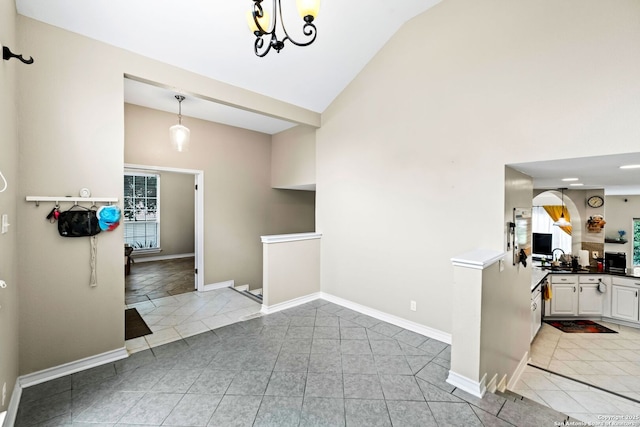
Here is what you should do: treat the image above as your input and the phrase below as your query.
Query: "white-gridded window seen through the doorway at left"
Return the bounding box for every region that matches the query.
[124,172,160,252]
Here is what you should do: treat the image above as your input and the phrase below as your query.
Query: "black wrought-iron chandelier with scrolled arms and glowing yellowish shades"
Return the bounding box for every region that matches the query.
[248,0,320,57]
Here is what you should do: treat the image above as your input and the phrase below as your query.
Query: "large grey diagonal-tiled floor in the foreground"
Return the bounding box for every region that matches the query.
[17,298,567,427]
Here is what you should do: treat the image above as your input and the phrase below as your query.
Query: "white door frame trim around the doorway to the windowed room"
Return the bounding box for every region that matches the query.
[124,163,204,291]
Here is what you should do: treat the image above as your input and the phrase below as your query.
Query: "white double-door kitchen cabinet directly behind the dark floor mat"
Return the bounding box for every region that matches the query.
[550,275,604,316]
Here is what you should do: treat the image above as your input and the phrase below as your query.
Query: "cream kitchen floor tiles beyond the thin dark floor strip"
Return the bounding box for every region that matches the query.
[531,321,640,404]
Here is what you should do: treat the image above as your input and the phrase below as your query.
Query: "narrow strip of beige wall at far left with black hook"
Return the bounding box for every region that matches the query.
[0,0,19,412]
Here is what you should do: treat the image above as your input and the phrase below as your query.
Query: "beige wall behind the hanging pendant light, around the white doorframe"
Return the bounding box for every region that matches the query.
[125,104,314,289]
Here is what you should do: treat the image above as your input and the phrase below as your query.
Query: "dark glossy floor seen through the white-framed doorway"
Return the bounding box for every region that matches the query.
[124,257,195,304]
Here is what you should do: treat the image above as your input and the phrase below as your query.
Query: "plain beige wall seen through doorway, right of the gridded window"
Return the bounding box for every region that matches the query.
[131,170,195,259]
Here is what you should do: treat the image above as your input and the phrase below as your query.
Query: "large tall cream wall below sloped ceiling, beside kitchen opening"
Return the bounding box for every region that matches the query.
[316,0,640,338]
